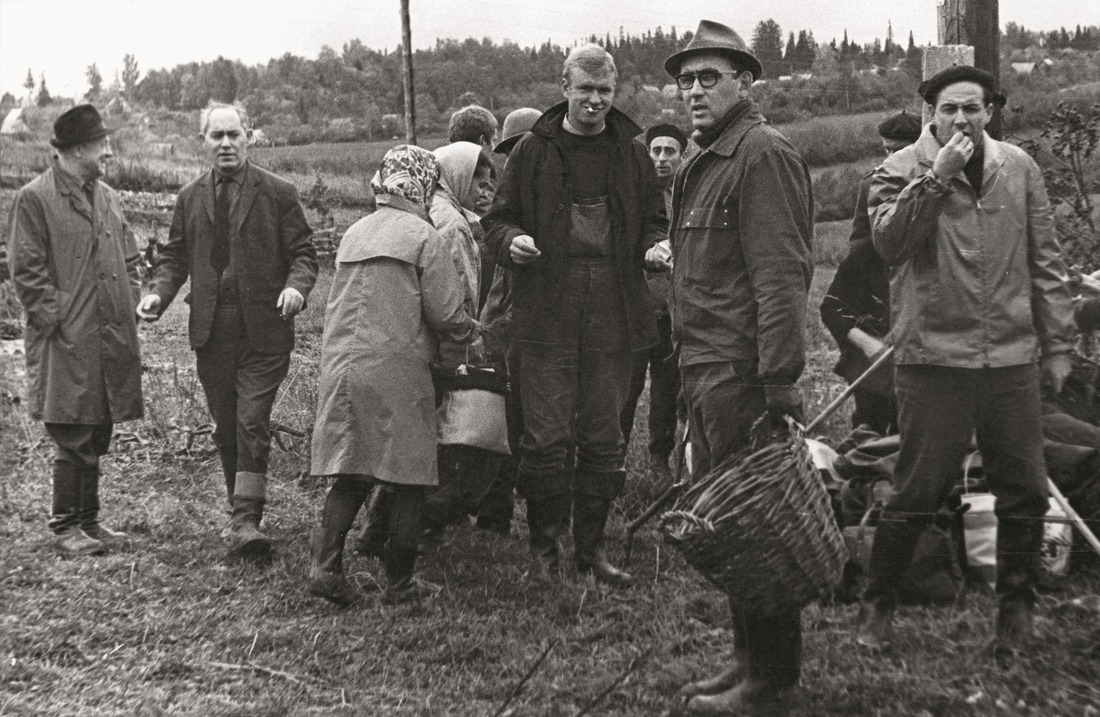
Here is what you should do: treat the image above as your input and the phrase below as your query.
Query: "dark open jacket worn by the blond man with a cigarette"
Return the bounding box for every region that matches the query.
[482,102,668,351]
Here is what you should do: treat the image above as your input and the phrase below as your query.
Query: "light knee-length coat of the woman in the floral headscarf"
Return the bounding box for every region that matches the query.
[311,195,475,485]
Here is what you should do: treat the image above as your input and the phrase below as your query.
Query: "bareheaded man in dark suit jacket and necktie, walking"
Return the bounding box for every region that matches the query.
[138,102,317,559]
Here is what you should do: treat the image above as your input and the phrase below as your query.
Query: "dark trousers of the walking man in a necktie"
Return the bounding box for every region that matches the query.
[195,305,290,497]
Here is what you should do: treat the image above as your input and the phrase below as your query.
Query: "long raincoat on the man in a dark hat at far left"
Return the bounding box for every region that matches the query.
[8,161,142,424]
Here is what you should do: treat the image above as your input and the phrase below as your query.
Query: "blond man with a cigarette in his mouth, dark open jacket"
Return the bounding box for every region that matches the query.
[482,44,667,586]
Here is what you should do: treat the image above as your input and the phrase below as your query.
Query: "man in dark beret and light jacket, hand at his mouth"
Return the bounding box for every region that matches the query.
[857,66,1074,652]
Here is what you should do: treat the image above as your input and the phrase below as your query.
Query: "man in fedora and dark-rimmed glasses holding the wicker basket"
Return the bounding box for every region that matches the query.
[649,20,814,714]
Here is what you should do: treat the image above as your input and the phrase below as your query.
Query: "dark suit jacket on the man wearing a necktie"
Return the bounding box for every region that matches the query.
[152,164,317,353]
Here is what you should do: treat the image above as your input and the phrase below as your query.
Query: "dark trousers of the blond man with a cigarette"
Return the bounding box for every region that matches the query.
[516,260,630,499]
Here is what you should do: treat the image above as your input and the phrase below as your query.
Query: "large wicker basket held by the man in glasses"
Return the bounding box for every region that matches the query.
[661,419,848,613]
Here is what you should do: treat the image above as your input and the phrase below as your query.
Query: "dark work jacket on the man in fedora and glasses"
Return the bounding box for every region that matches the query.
[670,104,814,385]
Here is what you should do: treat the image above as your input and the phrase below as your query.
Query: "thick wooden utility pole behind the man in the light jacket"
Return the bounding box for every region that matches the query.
[924,0,1001,140]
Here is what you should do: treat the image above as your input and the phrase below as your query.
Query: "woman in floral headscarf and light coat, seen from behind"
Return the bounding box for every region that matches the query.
[309,145,480,604]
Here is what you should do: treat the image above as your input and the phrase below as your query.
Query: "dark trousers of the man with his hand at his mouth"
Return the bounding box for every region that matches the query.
[883,364,1049,523]
